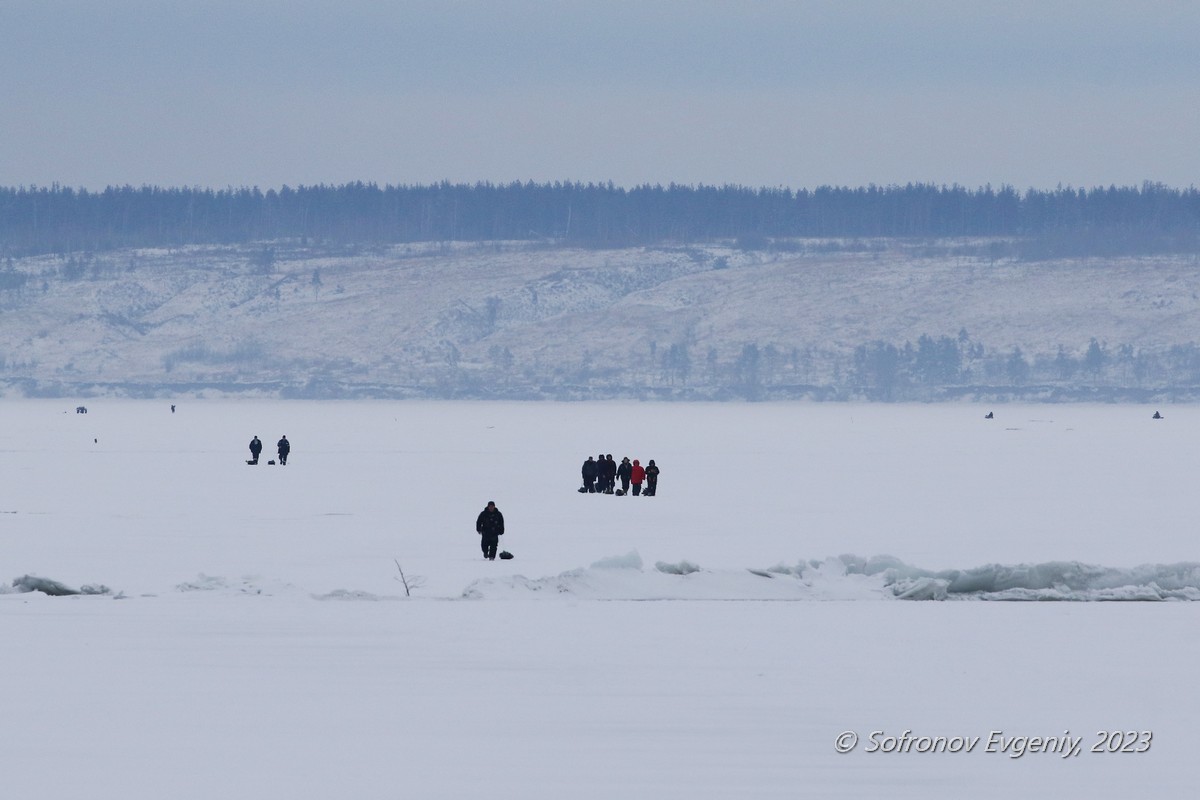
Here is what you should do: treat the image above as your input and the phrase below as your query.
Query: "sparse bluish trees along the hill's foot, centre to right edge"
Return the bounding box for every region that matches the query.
[456,329,1200,402]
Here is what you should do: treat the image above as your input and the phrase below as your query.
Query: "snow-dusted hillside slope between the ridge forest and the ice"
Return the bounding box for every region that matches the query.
[0,241,1200,399]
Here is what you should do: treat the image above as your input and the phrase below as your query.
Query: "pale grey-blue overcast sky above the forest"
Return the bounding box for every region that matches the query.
[0,0,1200,190]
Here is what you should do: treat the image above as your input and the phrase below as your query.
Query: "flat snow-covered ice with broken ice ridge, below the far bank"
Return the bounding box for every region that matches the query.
[0,399,1200,800]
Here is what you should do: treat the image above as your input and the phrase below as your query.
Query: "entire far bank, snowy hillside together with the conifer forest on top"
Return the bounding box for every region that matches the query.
[7,182,1200,401]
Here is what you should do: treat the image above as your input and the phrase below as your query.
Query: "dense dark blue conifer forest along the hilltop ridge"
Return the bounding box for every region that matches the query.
[0,182,1200,258]
